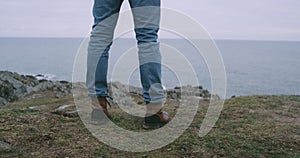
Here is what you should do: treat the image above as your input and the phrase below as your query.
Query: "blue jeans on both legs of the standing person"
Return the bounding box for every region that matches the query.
[86,0,164,103]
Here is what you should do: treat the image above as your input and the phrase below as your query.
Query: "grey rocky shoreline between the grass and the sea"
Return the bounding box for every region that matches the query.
[0,71,213,105]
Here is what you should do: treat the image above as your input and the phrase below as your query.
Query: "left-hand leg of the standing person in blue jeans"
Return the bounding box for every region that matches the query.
[86,0,123,97]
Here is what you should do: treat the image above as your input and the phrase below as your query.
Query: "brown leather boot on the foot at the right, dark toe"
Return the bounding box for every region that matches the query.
[143,109,170,129]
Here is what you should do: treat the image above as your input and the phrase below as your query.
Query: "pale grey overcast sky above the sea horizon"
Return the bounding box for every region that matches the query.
[0,0,300,41]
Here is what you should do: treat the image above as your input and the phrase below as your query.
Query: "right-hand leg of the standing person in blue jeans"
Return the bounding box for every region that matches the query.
[129,0,164,103]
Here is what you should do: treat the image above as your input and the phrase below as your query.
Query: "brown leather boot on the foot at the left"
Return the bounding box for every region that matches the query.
[91,97,112,125]
